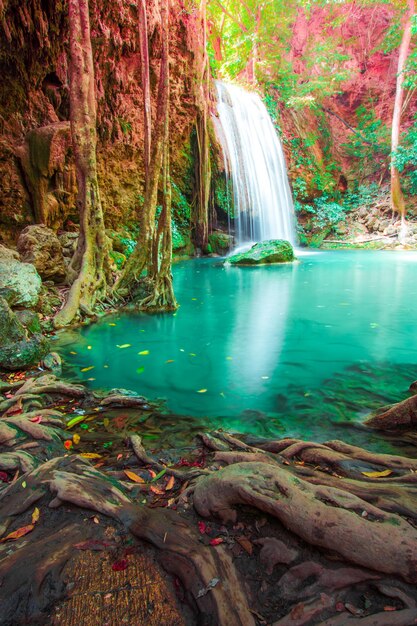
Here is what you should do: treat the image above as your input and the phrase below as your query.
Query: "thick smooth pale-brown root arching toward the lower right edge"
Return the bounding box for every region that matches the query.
[193,463,417,582]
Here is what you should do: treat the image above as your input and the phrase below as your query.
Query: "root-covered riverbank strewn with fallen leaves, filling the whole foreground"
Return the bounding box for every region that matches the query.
[0,364,417,626]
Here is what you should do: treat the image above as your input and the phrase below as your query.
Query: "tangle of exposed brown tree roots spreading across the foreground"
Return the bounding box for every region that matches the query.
[0,377,417,626]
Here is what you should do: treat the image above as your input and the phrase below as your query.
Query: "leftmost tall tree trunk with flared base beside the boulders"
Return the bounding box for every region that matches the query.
[54,0,108,327]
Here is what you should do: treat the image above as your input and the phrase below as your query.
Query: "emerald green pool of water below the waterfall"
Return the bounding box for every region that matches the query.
[57,251,417,447]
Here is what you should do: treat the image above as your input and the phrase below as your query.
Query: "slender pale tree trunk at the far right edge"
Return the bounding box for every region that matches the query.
[391,0,414,225]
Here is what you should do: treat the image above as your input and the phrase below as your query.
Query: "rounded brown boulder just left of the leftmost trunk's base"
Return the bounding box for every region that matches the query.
[17,224,66,282]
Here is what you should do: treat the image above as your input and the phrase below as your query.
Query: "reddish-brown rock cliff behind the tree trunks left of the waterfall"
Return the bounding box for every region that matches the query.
[0,0,200,242]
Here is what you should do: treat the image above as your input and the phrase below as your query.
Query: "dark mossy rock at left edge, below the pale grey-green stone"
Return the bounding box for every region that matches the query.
[0,297,49,370]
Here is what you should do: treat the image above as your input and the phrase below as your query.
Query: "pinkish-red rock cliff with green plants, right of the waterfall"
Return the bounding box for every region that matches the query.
[283,2,417,197]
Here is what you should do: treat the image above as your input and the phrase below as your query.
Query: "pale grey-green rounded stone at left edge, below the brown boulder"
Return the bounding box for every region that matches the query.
[0,259,42,308]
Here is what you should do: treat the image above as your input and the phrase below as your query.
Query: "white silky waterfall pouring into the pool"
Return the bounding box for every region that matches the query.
[216,82,295,245]
